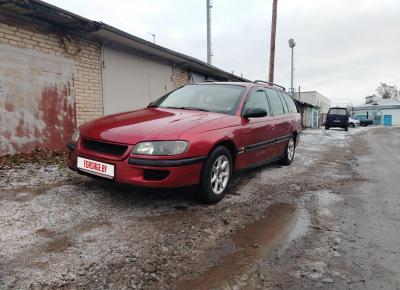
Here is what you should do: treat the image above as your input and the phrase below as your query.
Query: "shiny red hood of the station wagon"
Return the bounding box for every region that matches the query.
[80,108,227,144]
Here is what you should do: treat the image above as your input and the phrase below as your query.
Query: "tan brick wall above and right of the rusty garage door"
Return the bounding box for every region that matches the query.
[0,23,103,126]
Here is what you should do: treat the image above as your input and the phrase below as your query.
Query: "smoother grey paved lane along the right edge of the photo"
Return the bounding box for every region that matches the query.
[335,128,400,289]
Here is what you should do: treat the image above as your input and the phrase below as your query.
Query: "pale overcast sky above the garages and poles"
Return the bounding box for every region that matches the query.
[47,0,400,105]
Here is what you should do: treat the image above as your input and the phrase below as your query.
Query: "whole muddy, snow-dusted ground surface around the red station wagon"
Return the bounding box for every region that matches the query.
[0,128,400,289]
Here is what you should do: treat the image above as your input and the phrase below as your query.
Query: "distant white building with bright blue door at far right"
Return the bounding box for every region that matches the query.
[351,96,400,126]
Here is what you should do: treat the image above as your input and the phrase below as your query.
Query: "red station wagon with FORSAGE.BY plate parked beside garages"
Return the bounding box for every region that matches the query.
[68,81,301,203]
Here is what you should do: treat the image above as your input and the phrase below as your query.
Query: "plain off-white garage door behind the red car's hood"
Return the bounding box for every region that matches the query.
[103,47,173,115]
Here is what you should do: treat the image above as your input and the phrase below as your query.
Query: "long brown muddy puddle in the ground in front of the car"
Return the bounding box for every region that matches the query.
[176,203,309,289]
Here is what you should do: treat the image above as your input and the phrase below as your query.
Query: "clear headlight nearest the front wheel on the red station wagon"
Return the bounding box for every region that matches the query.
[132,141,188,155]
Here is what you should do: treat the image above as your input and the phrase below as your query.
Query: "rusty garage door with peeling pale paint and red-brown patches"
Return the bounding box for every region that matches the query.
[0,45,75,155]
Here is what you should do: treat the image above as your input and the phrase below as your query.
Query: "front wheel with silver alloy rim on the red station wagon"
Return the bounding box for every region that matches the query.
[198,146,233,204]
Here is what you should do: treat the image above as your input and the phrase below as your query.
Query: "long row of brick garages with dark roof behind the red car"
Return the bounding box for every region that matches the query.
[0,0,245,155]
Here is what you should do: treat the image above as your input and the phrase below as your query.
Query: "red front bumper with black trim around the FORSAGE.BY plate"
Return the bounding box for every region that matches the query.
[67,144,205,188]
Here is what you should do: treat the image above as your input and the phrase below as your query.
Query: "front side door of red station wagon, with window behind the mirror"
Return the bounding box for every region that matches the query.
[241,87,275,167]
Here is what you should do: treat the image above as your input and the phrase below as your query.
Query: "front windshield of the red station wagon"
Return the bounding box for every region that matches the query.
[154,85,245,115]
